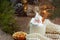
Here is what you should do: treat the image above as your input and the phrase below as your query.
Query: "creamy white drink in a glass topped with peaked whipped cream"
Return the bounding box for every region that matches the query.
[30,12,46,35]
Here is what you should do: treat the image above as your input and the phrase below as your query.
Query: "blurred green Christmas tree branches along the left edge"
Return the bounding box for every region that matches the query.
[0,0,16,34]
